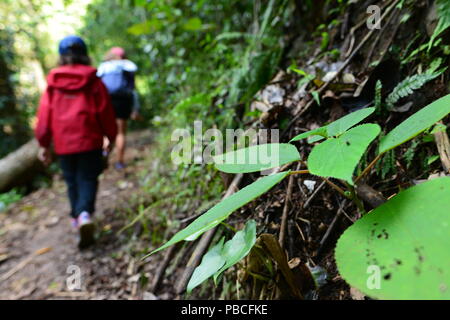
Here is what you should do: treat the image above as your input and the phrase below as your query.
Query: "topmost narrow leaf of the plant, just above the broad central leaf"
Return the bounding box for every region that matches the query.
[290,108,375,142]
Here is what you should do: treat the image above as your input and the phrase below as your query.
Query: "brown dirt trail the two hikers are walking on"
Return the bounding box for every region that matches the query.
[0,131,168,299]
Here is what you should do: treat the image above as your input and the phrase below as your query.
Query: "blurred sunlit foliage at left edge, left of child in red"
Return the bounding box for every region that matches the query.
[0,0,85,157]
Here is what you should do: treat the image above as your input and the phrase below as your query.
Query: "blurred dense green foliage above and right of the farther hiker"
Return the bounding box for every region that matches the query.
[82,0,290,127]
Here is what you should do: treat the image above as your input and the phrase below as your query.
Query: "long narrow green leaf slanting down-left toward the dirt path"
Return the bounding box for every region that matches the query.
[150,171,290,254]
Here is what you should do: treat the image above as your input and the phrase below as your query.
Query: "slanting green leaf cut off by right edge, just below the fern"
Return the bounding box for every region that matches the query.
[379,94,450,154]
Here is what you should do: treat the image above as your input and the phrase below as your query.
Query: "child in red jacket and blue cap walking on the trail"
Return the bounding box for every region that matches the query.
[35,36,117,248]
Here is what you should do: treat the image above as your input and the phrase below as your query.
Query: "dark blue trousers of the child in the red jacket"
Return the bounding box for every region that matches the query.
[59,150,103,218]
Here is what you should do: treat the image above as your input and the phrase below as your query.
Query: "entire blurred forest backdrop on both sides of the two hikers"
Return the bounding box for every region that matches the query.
[0,0,295,195]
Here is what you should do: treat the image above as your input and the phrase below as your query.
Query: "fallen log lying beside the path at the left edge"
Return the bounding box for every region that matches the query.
[0,139,41,192]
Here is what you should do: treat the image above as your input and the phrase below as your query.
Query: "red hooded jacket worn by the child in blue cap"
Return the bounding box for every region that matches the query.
[35,64,117,155]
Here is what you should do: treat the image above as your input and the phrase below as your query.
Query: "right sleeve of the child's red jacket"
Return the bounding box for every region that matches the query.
[95,79,117,145]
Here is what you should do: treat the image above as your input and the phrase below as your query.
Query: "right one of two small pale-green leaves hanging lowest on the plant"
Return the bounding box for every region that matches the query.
[214,220,256,281]
